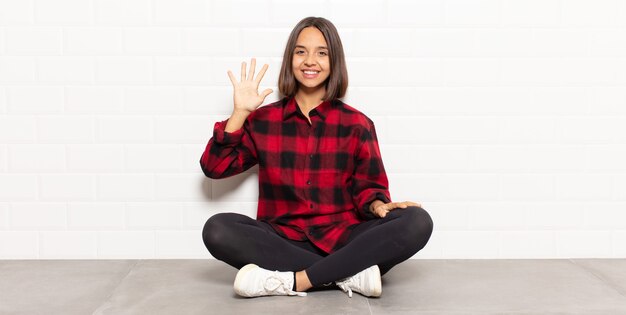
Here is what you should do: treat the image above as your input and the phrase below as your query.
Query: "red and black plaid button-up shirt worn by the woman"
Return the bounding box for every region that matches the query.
[200,97,391,253]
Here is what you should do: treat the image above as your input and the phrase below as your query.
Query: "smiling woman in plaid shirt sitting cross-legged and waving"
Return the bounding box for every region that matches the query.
[200,17,433,297]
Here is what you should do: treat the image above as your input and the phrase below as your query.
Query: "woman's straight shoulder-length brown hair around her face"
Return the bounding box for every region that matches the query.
[278,16,348,101]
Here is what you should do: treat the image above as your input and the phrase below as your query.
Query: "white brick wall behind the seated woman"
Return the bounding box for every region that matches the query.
[0,0,626,259]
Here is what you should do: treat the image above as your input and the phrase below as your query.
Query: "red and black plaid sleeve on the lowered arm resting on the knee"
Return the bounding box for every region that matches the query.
[352,123,391,220]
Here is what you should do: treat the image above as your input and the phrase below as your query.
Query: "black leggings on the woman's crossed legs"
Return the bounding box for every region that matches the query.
[202,206,433,287]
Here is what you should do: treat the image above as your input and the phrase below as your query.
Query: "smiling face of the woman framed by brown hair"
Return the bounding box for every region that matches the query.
[292,26,330,89]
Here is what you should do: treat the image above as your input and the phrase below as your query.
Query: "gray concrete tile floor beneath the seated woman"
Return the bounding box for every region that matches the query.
[0,259,626,314]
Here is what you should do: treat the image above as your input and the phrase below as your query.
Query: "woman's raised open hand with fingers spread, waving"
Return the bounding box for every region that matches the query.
[228,58,273,114]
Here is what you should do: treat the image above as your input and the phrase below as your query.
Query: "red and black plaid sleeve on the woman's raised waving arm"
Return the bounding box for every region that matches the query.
[200,115,258,179]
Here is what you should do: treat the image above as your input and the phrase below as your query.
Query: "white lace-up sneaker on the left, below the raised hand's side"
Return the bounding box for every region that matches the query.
[234,264,306,297]
